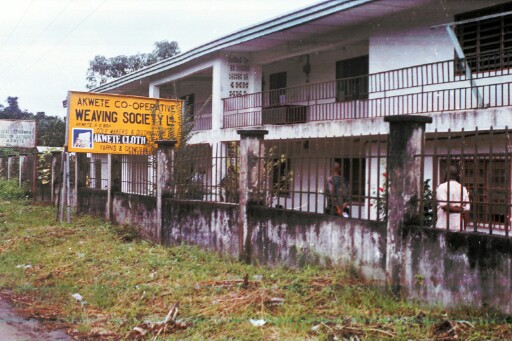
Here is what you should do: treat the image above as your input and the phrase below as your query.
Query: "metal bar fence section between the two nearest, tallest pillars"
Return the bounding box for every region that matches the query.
[251,135,387,221]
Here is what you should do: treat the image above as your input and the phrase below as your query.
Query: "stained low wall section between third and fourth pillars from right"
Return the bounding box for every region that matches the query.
[111,193,160,243]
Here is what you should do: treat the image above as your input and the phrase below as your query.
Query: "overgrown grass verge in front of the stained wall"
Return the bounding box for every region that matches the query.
[0,195,512,340]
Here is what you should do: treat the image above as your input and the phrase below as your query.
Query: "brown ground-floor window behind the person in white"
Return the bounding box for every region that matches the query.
[440,157,510,224]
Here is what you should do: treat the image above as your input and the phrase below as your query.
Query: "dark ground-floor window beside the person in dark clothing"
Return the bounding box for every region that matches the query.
[334,158,366,203]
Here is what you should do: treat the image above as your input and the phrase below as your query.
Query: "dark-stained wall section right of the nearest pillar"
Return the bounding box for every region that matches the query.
[403,227,512,314]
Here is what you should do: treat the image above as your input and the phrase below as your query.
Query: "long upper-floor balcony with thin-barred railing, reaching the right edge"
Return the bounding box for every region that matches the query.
[223,53,512,128]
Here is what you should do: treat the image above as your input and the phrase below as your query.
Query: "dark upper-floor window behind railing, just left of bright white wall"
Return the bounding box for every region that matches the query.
[336,55,368,102]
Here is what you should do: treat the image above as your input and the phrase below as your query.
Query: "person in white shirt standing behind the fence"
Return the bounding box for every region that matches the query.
[436,165,470,231]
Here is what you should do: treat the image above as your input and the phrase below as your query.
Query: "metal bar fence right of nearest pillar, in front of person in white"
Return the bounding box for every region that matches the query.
[418,127,512,236]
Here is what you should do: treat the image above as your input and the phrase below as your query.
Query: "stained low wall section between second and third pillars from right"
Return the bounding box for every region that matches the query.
[162,199,239,257]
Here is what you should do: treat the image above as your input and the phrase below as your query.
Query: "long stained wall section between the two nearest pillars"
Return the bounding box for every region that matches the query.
[249,207,386,281]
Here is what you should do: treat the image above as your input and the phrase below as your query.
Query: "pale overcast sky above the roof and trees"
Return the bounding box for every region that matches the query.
[0,0,319,117]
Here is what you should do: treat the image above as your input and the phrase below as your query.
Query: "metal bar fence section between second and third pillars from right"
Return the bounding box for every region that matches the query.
[173,142,240,203]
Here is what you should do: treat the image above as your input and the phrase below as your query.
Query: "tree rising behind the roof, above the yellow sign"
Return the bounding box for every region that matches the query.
[86,40,180,89]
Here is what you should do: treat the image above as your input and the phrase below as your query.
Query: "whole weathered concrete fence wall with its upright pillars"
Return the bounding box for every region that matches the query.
[70,116,512,313]
